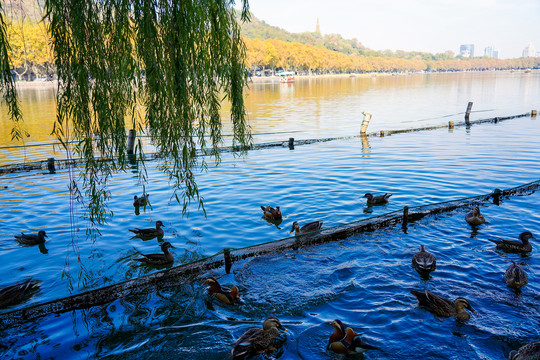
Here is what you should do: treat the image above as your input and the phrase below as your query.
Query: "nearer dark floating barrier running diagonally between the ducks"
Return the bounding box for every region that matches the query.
[0,180,540,330]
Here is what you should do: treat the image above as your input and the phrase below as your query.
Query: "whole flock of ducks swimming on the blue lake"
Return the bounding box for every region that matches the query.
[0,193,540,360]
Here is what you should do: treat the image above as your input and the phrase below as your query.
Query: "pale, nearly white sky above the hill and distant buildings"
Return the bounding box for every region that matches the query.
[242,0,540,59]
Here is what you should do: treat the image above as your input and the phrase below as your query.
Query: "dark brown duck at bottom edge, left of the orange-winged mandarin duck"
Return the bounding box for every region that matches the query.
[231,316,287,359]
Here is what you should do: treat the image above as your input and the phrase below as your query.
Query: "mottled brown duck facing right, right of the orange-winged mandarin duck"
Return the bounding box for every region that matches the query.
[411,290,476,322]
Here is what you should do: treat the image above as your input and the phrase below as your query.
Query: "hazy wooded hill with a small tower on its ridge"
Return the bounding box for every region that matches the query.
[238,13,370,55]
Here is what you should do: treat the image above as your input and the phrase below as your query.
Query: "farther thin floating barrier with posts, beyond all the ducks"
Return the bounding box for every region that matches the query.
[0,113,531,175]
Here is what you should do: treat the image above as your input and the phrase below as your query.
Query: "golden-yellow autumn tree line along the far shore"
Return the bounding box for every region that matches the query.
[7,21,540,80]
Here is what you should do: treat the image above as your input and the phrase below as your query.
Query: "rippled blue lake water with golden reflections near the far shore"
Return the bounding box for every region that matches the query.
[0,72,540,359]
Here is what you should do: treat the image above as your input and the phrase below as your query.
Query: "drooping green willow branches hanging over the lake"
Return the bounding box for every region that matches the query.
[0,0,251,223]
